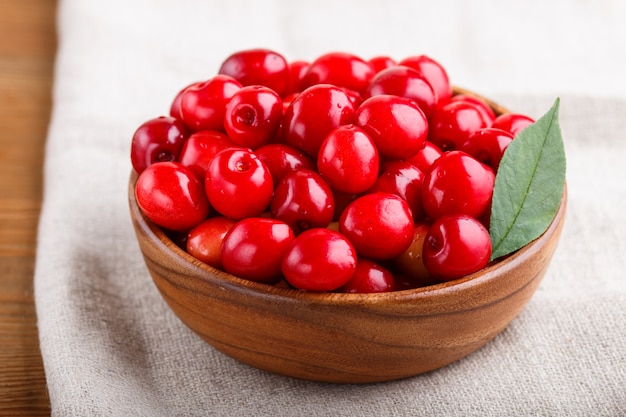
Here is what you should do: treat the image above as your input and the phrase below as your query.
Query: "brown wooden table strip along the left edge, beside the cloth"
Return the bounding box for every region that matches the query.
[0,0,57,416]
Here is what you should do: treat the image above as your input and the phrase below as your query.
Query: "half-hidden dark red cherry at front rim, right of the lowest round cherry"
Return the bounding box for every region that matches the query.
[339,258,395,294]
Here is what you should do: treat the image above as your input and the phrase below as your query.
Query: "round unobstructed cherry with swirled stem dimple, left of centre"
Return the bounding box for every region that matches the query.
[205,148,274,220]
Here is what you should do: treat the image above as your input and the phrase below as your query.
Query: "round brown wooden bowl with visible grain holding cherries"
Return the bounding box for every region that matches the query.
[128,92,567,383]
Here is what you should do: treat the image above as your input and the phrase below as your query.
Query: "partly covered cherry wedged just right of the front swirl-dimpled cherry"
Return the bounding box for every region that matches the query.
[254,143,315,186]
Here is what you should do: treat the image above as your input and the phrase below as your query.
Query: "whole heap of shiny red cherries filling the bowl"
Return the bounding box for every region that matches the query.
[131,49,533,293]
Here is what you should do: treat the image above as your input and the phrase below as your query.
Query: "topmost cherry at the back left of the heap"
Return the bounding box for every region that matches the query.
[219,49,289,96]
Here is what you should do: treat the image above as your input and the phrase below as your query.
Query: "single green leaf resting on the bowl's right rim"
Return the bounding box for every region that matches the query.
[489,98,565,260]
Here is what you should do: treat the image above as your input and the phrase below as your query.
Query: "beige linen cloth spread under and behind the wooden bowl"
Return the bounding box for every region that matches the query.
[35,0,626,417]
